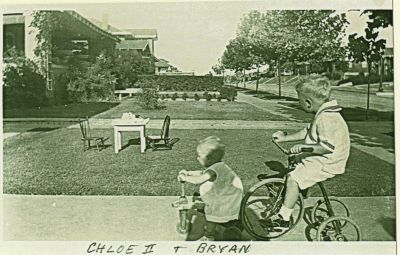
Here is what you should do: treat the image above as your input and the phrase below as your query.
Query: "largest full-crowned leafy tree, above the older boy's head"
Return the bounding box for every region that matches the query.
[245,10,347,96]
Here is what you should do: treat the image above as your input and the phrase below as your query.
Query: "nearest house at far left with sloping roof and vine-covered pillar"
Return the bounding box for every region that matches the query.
[3,11,120,103]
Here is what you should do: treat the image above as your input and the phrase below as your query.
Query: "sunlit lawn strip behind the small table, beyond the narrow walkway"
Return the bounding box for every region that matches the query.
[92,99,282,121]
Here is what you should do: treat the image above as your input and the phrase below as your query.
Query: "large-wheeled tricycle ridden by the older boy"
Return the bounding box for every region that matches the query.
[240,140,361,241]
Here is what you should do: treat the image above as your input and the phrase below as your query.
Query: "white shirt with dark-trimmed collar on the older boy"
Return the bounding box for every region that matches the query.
[305,100,350,174]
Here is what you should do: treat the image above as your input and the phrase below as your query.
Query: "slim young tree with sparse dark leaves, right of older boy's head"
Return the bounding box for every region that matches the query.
[348,11,386,119]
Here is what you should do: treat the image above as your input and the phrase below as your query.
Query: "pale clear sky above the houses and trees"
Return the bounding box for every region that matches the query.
[3,0,393,74]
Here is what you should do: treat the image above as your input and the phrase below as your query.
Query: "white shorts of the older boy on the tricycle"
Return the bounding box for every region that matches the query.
[290,158,335,190]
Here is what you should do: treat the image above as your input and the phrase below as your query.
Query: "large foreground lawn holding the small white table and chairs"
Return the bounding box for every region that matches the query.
[3,128,395,196]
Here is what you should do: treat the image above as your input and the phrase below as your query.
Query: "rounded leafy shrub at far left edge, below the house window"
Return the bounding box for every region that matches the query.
[3,50,48,108]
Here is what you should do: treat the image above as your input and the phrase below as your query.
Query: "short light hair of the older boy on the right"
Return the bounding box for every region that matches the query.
[296,75,331,102]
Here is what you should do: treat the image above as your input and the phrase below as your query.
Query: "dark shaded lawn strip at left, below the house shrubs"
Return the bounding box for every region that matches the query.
[3,102,119,118]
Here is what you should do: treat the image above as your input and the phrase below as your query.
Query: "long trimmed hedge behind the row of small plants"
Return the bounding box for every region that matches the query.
[135,75,223,91]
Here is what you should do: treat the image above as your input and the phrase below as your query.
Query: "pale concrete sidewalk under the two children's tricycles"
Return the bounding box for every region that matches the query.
[2,195,395,241]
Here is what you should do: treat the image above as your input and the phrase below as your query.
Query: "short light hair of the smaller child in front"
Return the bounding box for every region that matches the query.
[197,136,225,165]
